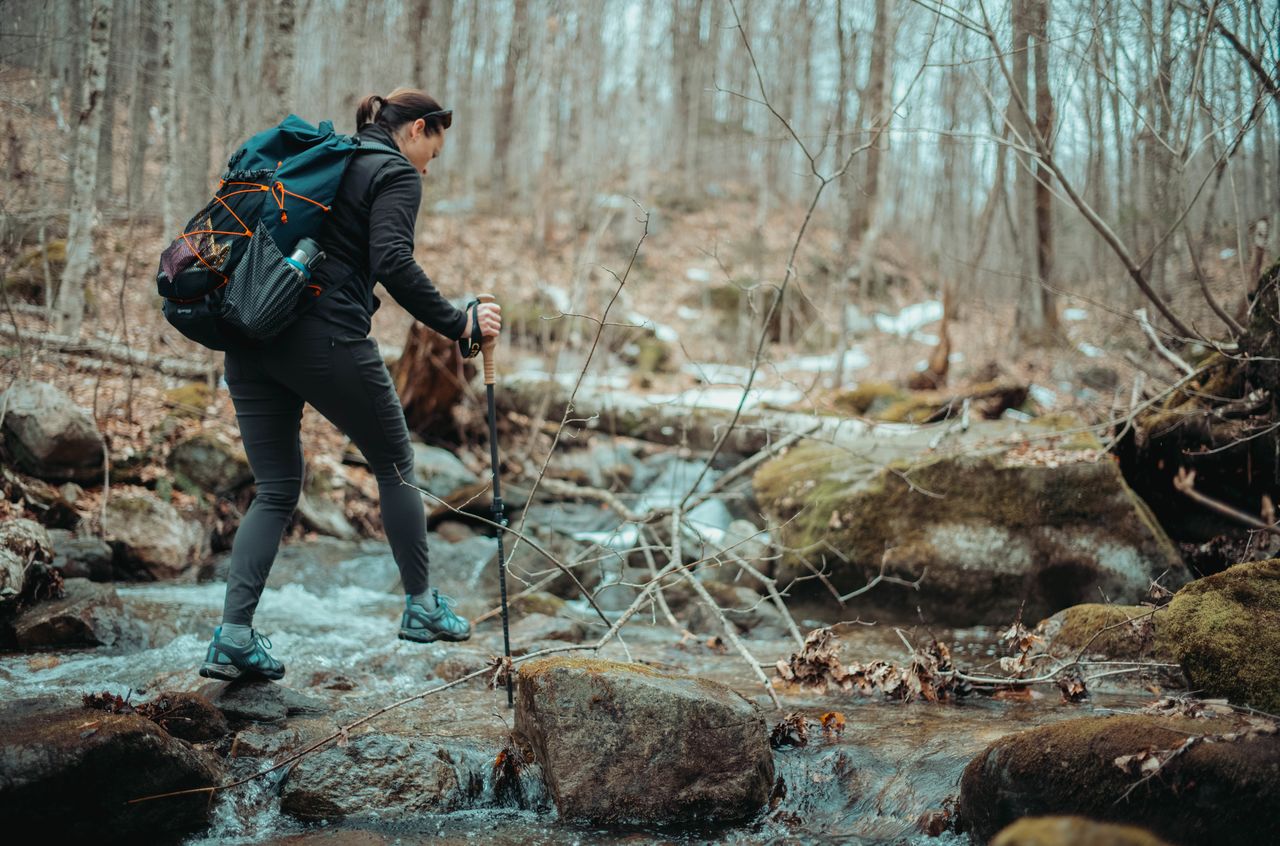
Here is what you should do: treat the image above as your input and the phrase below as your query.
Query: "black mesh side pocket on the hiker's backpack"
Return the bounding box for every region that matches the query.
[221,224,307,340]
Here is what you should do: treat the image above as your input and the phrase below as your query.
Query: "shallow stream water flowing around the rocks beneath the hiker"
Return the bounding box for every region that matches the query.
[0,538,1157,846]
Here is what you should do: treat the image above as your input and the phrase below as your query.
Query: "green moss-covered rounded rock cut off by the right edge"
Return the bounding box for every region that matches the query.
[1161,558,1280,713]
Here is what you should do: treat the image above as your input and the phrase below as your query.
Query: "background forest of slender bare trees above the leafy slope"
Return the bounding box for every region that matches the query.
[0,0,1280,335]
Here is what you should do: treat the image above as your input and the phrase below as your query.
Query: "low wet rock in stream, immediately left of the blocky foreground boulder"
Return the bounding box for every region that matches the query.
[280,732,495,822]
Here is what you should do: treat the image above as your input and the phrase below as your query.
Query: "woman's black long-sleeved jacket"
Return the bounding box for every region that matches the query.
[310,124,466,339]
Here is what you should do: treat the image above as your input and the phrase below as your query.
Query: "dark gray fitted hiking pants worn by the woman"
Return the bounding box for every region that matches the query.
[223,316,428,626]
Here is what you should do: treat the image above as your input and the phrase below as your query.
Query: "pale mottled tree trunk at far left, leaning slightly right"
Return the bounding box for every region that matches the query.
[55,0,111,338]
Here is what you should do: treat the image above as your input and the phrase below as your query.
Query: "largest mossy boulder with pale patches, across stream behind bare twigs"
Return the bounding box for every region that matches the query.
[754,422,1189,625]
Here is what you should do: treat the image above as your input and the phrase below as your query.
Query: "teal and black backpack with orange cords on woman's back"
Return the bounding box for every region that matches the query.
[156,114,399,349]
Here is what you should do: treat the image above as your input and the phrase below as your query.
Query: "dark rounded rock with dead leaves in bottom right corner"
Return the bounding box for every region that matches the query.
[960,714,1280,846]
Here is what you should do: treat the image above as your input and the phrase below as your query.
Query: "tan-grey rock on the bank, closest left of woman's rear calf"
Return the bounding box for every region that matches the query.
[102,493,207,579]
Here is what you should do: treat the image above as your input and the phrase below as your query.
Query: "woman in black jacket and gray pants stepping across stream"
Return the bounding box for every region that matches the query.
[200,88,502,680]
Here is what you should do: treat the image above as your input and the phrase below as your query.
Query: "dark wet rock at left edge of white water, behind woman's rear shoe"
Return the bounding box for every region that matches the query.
[13,579,127,649]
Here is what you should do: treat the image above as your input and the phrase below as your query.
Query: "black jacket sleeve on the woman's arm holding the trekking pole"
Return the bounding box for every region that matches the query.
[369,159,467,340]
